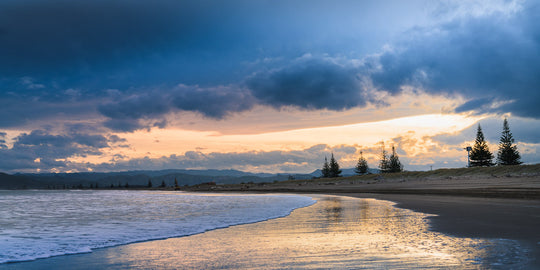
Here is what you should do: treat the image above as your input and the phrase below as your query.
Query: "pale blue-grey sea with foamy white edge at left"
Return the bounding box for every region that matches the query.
[0,190,315,263]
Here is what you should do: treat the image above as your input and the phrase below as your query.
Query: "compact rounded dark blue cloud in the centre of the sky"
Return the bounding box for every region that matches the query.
[247,57,366,110]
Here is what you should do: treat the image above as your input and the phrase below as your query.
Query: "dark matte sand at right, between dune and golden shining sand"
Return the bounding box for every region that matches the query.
[348,194,540,269]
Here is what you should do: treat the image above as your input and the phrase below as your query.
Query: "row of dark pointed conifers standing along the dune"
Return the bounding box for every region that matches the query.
[321,118,522,178]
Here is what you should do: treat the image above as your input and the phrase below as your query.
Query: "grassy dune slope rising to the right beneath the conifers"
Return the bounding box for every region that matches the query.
[187,164,540,199]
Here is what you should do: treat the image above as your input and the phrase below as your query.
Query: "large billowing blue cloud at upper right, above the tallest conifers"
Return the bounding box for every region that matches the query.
[371,4,540,118]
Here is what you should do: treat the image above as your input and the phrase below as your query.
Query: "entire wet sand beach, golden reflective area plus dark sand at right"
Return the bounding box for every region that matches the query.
[0,194,539,269]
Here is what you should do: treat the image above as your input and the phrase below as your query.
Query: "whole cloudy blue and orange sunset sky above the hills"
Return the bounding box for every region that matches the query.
[0,0,540,173]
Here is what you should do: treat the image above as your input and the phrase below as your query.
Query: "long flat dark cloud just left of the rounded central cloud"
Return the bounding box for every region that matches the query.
[99,85,255,131]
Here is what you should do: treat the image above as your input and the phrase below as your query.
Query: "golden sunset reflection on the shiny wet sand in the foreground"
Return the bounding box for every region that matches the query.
[96,195,519,269]
